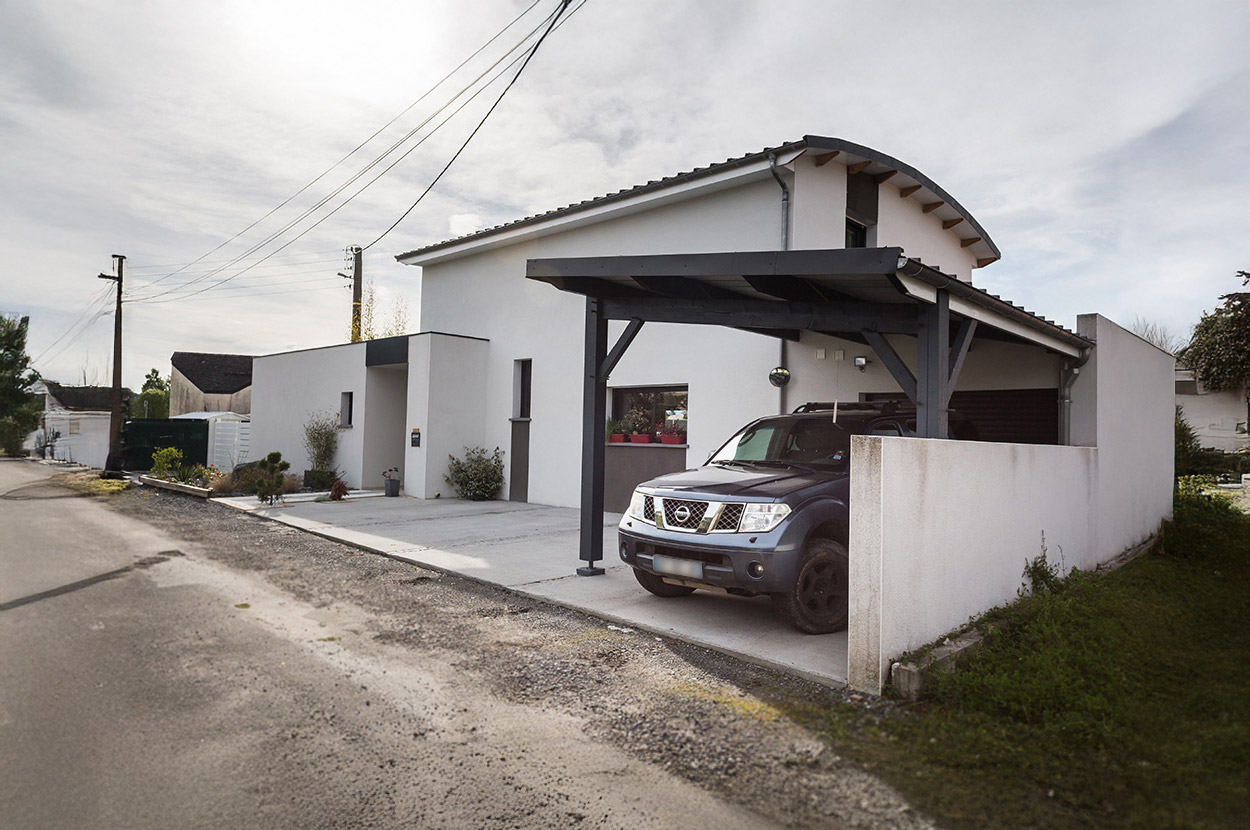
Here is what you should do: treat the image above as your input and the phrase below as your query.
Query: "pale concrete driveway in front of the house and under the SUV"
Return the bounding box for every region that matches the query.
[218,494,846,685]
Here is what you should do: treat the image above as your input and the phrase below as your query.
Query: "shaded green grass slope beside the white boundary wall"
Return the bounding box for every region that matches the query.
[795,491,1250,828]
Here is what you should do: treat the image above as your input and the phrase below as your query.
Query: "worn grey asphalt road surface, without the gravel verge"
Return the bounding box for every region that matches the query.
[0,463,768,830]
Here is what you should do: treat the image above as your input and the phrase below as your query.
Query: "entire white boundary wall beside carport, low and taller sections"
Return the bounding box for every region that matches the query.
[848,315,1174,694]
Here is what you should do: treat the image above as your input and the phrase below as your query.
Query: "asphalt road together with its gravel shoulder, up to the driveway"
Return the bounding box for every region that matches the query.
[0,461,931,830]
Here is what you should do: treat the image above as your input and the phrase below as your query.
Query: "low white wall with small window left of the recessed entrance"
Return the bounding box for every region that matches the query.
[251,343,365,488]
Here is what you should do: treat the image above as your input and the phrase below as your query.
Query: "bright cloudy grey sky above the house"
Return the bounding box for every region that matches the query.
[0,0,1250,389]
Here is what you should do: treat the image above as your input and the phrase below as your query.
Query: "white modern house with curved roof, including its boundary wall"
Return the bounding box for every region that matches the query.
[251,136,1174,690]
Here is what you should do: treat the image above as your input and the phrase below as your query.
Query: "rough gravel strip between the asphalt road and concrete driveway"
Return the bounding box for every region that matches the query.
[108,488,933,828]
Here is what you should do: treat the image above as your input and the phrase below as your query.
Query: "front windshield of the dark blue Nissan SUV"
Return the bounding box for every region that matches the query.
[709,418,851,470]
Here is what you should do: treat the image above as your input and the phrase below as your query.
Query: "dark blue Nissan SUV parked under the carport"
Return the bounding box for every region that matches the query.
[619,404,971,634]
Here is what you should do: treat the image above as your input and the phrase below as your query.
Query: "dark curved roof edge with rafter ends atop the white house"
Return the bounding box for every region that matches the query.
[395,135,1003,268]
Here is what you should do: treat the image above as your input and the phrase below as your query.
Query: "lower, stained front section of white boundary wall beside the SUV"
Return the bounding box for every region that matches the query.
[848,436,1095,694]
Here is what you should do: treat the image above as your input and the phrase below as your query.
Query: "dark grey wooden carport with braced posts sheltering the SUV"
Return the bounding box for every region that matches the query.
[526,248,1093,576]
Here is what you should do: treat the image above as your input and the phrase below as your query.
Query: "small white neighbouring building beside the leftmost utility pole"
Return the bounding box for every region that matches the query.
[35,380,131,469]
